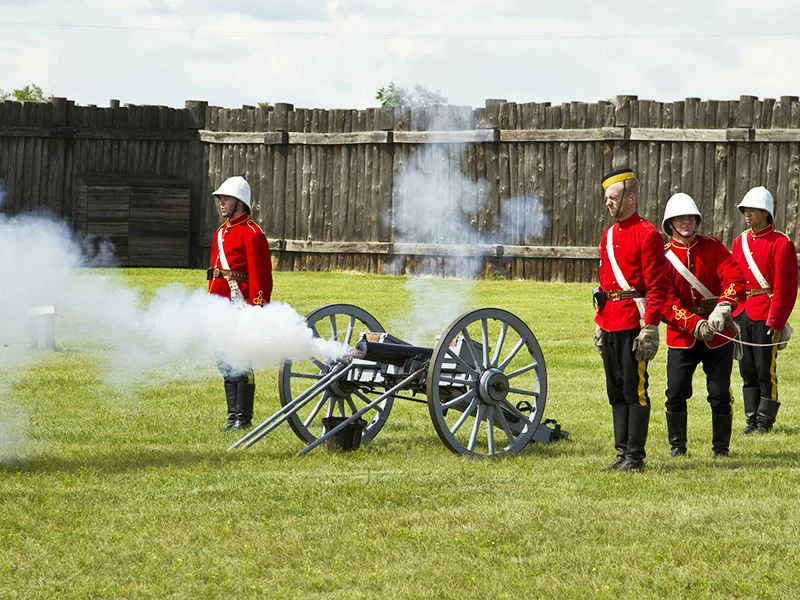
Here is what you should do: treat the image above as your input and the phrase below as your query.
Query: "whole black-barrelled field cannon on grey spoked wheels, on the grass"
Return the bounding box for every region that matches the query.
[230,304,568,456]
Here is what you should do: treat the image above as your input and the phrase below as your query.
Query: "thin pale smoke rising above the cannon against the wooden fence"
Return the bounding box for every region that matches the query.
[391,111,550,346]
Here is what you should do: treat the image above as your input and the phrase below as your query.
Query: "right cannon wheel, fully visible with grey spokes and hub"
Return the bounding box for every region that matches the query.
[427,308,547,456]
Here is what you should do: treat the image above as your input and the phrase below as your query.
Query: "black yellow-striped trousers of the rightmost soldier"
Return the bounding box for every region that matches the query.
[736,313,778,402]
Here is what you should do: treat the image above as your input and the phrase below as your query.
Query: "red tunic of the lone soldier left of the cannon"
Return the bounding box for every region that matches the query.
[208,214,272,305]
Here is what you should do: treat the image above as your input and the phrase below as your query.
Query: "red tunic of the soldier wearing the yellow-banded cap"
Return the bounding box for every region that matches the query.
[594,212,669,331]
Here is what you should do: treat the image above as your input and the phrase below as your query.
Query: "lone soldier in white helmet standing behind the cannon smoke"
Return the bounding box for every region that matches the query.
[208,176,272,431]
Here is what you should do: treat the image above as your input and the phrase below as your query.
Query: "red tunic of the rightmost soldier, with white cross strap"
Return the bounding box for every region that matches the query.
[732,225,797,329]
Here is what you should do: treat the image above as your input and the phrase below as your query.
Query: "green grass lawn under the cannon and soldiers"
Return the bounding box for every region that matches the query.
[0,269,800,599]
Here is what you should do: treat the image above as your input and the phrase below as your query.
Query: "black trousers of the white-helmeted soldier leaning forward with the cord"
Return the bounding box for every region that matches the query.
[664,341,733,415]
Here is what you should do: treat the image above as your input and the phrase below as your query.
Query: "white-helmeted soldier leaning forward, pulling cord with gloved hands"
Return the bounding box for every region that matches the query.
[661,193,744,458]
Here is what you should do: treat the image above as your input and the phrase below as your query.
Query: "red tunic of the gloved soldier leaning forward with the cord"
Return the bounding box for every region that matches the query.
[662,235,744,348]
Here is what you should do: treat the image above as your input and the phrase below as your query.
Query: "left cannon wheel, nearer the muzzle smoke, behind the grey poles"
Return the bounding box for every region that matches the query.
[278,304,393,444]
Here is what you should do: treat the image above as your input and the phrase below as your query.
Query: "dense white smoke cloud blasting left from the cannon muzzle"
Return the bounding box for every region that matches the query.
[0,214,348,458]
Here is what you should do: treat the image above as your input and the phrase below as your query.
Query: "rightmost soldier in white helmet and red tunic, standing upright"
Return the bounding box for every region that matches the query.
[732,186,797,434]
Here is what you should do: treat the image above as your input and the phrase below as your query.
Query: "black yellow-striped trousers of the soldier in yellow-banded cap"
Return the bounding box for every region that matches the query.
[601,327,650,406]
